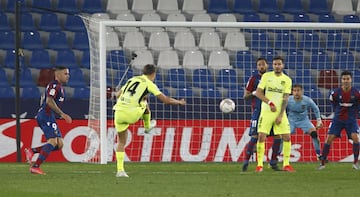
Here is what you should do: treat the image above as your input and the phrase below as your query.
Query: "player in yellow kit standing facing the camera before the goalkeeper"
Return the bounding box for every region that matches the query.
[256,57,294,172]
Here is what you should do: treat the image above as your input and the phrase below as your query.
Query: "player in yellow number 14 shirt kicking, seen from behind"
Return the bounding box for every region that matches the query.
[113,64,186,177]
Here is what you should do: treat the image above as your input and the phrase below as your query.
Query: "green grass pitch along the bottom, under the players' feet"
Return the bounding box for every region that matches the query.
[0,162,360,197]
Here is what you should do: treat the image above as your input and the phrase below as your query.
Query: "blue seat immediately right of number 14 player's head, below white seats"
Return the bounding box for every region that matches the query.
[166,68,187,88]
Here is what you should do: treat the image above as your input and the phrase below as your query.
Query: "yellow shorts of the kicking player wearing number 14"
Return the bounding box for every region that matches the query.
[114,107,146,132]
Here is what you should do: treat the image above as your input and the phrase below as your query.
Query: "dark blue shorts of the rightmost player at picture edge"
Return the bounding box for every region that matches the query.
[328,120,359,139]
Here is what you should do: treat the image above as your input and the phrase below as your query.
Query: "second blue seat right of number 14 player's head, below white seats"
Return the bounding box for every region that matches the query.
[192,68,214,89]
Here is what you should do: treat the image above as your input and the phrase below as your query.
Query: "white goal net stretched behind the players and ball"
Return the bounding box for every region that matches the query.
[83,17,360,163]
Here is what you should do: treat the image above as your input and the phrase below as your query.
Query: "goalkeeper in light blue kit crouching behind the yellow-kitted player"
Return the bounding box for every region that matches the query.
[287,84,323,159]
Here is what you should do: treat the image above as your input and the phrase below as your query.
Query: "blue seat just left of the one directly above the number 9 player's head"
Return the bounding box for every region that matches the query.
[29,49,53,69]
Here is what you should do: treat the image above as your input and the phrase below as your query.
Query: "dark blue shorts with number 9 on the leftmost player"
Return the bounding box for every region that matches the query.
[36,113,62,140]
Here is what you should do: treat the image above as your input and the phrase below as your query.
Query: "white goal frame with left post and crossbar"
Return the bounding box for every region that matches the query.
[81,16,359,164]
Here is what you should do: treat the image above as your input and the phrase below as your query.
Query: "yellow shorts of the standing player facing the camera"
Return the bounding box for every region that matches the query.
[258,113,290,135]
